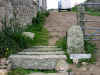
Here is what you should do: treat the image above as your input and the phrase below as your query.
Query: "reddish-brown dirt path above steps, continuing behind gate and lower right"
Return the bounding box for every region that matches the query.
[45,12,100,75]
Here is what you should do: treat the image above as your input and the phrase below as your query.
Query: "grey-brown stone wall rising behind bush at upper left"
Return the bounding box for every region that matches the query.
[0,0,38,25]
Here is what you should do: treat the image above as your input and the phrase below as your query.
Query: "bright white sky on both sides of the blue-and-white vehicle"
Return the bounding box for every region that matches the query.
[47,0,86,9]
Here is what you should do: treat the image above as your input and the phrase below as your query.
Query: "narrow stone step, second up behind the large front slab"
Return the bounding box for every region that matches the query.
[23,47,62,52]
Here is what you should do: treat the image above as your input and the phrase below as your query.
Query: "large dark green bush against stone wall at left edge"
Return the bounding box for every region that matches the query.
[0,18,32,57]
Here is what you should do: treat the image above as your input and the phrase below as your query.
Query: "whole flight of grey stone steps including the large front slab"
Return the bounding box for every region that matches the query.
[9,46,67,70]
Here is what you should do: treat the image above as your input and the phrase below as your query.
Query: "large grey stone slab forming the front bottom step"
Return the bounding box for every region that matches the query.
[9,55,66,70]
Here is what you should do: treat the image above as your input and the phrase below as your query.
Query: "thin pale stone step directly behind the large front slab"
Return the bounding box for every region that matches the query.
[18,51,64,55]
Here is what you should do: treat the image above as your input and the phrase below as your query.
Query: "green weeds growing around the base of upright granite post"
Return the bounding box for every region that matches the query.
[56,37,97,64]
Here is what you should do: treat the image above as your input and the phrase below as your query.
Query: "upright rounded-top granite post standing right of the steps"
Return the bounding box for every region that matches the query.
[67,25,85,54]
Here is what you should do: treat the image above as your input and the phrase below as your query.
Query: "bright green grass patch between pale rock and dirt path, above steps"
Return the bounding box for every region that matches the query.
[26,27,49,46]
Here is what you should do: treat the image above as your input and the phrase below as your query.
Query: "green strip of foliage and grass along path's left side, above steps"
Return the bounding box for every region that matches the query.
[26,12,49,45]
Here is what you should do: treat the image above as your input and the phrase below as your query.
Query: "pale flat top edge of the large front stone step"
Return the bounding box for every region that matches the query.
[9,55,67,59]
